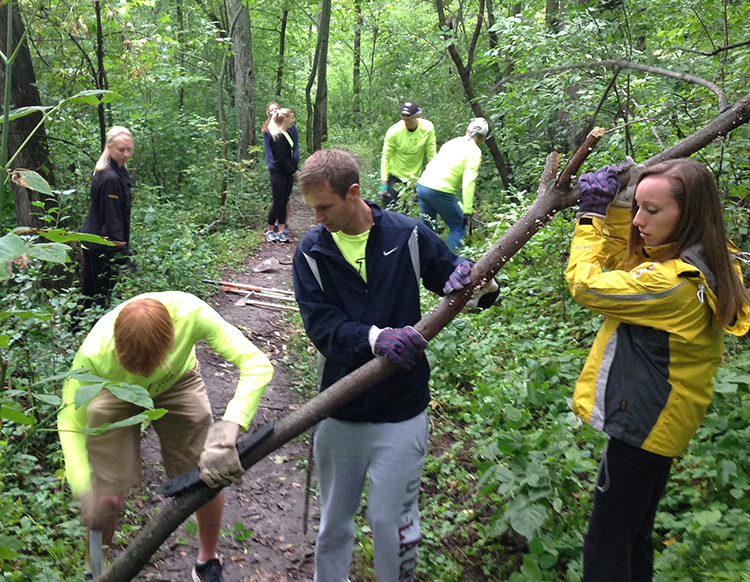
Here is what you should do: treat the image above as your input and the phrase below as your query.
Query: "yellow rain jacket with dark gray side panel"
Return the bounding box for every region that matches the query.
[566,208,750,457]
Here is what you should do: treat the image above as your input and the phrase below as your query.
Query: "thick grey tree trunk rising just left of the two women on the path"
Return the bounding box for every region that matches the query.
[232,0,255,161]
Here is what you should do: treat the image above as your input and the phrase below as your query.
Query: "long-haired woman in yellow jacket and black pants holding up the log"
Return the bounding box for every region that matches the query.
[566,159,750,582]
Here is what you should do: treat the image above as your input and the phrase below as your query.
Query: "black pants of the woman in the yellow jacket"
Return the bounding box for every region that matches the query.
[583,438,672,582]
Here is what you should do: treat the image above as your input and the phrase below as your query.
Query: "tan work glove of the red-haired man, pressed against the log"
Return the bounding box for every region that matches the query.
[198,420,245,489]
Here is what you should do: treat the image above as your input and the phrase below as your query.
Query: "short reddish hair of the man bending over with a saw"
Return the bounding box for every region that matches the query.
[115,298,174,378]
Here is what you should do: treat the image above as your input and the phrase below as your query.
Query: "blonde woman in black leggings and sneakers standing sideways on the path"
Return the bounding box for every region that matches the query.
[264,109,298,242]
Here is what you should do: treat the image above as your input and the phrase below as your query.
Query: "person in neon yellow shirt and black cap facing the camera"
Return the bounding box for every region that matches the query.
[380,101,437,207]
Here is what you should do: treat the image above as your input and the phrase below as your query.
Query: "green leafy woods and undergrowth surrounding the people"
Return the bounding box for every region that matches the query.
[0,0,750,581]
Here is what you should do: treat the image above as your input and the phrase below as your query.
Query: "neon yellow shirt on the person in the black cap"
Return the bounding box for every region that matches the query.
[380,119,437,182]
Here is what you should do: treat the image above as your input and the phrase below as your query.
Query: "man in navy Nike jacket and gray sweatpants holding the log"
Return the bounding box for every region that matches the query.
[293,150,496,582]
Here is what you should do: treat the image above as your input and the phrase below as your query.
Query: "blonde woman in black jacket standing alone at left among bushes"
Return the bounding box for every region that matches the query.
[79,126,133,320]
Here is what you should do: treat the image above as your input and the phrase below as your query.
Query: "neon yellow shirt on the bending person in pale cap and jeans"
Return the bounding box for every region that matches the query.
[419,135,482,214]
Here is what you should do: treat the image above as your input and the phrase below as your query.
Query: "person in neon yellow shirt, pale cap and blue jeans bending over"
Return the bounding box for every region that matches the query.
[417,117,490,252]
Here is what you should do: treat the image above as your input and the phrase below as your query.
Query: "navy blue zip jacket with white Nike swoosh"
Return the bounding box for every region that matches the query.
[293,202,464,422]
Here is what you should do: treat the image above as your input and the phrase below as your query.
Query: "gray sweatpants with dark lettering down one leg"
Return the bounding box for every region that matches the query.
[314,412,428,582]
